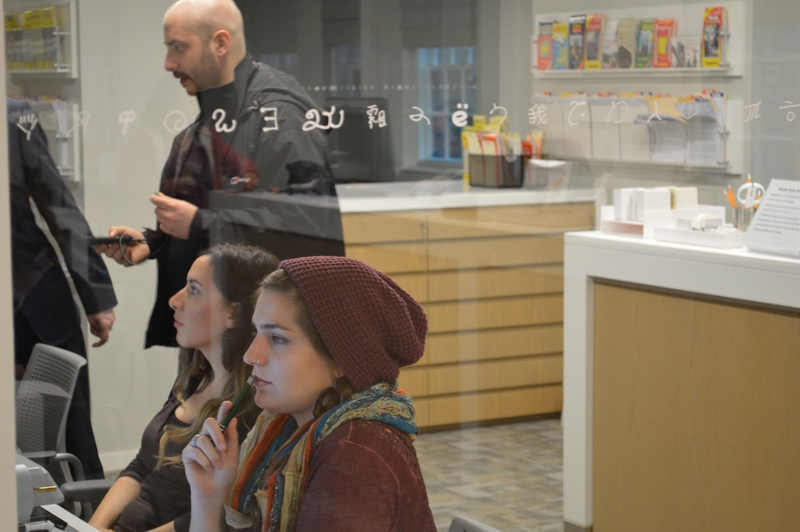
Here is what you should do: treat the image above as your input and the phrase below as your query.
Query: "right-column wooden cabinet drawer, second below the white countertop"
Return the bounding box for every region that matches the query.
[428,235,564,271]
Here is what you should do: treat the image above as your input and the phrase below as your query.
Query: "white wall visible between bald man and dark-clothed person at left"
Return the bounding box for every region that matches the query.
[79,0,197,471]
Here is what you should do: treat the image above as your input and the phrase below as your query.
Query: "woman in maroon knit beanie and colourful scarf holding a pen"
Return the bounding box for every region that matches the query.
[183,257,436,532]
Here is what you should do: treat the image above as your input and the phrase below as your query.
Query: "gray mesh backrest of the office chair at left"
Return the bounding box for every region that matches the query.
[16,344,86,484]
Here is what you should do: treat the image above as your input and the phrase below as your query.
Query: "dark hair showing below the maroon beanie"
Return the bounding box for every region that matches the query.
[260,269,353,418]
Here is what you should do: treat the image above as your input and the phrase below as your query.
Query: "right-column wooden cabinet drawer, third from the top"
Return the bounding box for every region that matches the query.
[427,266,564,301]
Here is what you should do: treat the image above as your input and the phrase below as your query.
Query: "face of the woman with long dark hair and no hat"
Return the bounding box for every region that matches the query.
[169,255,233,356]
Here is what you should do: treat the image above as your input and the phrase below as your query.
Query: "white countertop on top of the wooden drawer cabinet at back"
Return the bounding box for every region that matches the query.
[336,180,606,214]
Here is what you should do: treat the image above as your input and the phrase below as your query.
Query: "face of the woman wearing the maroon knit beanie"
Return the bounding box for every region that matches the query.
[244,290,335,425]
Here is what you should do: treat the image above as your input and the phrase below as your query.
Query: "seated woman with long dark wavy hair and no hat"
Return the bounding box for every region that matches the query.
[90,245,278,532]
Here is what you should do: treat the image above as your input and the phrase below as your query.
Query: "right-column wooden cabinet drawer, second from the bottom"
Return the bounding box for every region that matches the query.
[427,354,564,396]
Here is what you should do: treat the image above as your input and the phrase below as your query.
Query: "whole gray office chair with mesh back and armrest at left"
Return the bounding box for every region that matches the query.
[16,344,113,519]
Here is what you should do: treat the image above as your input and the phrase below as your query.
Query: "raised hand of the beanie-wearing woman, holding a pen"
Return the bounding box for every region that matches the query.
[183,401,239,504]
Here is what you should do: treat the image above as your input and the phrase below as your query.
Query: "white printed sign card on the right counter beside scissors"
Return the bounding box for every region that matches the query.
[743,179,800,257]
